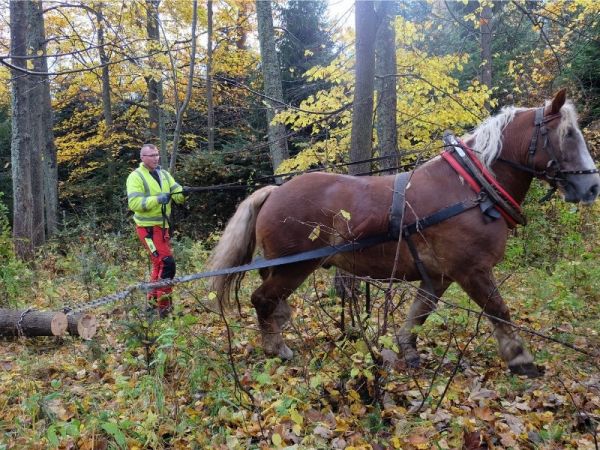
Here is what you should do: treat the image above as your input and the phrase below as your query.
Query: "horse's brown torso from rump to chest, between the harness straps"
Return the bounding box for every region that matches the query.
[256,165,506,278]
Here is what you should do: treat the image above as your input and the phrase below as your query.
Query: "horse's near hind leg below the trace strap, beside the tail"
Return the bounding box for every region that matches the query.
[252,261,317,359]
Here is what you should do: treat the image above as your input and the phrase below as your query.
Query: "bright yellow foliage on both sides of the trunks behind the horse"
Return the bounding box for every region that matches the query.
[274,13,490,173]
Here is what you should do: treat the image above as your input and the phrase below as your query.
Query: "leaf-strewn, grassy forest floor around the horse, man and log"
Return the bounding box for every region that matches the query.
[0,206,600,450]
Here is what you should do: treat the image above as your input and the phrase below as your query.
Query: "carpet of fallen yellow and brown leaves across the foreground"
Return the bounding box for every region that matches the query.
[0,253,600,450]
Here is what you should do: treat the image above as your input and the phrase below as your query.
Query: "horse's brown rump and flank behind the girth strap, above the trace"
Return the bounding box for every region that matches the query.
[256,172,394,257]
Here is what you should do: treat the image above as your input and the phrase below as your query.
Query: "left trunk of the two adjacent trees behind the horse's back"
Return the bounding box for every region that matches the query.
[348,0,377,174]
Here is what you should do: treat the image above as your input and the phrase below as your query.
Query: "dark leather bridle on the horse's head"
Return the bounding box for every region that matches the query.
[498,107,598,188]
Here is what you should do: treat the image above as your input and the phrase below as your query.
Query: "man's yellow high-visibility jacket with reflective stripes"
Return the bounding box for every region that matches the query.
[127,163,185,227]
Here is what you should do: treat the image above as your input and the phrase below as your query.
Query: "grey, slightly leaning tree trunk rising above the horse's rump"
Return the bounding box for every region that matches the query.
[256,0,289,172]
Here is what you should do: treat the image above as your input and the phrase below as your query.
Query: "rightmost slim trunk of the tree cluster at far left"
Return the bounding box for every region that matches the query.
[31,1,58,238]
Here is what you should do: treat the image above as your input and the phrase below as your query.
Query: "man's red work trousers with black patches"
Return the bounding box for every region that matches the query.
[136,225,175,310]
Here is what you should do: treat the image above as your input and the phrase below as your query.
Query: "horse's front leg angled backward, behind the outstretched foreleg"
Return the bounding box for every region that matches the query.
[396,277,451,367]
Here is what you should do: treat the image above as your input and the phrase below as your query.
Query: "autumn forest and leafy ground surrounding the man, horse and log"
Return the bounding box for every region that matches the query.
[0,0,600,448]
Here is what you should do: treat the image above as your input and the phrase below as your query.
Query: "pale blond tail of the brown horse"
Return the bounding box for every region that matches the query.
[208,186,277,307]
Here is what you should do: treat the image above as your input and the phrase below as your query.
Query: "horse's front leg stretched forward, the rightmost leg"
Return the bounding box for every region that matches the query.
[457,270,541,377]
